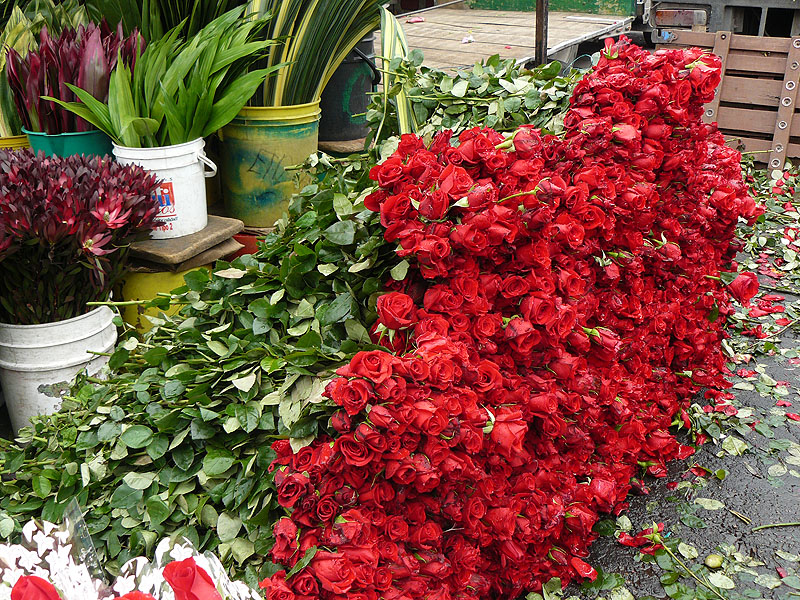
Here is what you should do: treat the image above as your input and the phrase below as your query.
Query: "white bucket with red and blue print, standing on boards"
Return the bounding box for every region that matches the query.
[113,138,217,240]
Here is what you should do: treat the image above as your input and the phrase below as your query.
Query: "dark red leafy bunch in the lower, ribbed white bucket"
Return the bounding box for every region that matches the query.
[0,150,157,325]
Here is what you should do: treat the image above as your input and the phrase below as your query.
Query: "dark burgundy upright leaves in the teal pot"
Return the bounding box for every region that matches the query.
[6,21,143,135]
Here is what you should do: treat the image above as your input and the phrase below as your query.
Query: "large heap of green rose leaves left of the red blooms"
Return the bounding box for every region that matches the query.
[0,165,395,583]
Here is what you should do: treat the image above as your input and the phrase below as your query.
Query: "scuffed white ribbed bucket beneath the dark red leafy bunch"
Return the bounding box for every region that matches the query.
[0,306,117,433]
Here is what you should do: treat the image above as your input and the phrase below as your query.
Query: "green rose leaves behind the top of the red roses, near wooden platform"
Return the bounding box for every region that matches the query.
[367,50,584,140]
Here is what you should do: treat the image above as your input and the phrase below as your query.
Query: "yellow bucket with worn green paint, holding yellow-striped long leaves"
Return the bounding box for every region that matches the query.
[219,102,320,227]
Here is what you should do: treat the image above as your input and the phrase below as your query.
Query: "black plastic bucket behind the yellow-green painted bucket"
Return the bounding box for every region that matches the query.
[319,34,380,142]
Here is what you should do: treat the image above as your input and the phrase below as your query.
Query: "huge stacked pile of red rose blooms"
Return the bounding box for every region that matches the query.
[262,39,760,600]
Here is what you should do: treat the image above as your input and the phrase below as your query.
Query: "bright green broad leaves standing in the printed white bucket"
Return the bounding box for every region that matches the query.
[50,7,276,148]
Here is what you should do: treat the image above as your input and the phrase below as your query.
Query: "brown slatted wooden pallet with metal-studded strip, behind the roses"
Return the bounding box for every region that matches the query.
[662,30,800,169]
